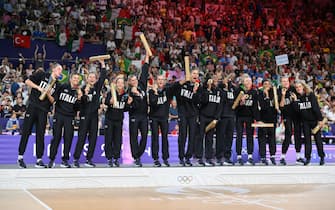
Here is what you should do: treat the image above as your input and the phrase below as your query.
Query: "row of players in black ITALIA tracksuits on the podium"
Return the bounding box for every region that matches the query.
[18,55,325,168]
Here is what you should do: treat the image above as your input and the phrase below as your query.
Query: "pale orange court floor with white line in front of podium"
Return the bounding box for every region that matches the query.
[0,184,335,210]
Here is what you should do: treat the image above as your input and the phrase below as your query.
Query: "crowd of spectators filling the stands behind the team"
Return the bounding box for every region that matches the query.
[0,0,335,141]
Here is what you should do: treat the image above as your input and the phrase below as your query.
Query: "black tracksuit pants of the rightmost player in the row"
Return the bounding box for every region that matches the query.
[303,121,325,159]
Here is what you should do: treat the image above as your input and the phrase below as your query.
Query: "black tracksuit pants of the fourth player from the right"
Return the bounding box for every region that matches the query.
[236,117,254,155]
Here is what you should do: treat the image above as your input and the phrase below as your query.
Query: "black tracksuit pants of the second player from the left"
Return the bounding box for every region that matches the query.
[49,113,74,160]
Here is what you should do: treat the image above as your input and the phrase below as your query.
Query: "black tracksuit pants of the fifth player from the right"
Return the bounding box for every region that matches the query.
[215,117,235,160]
